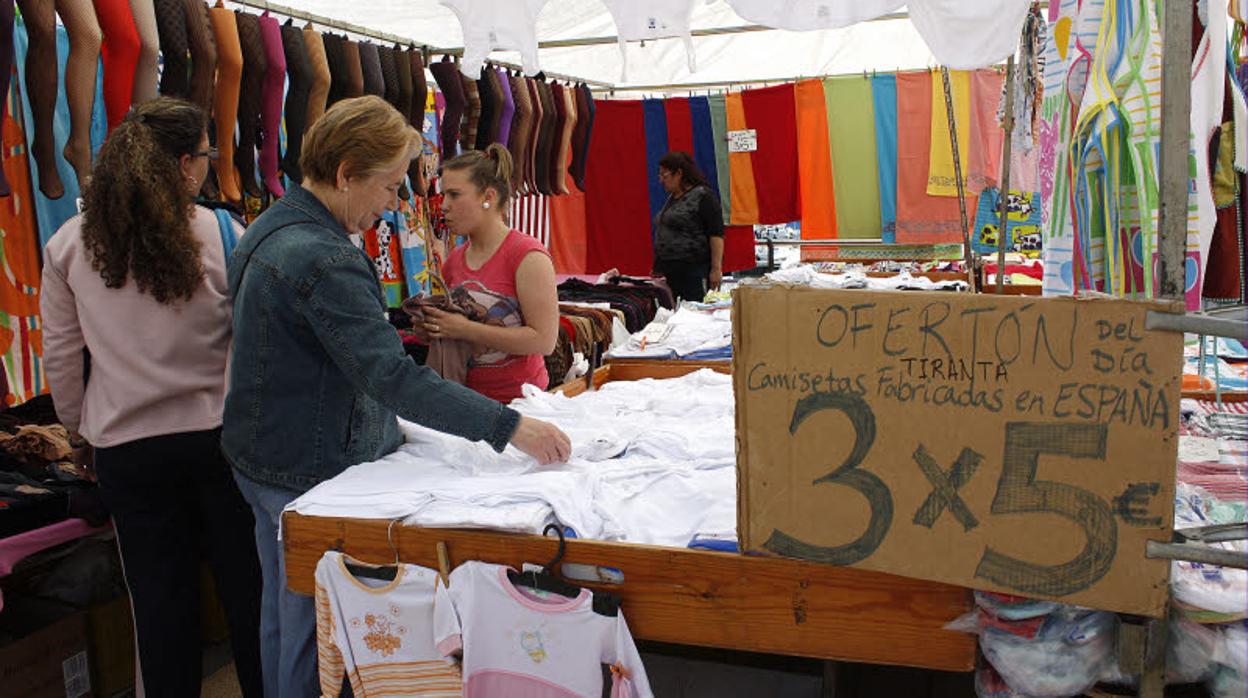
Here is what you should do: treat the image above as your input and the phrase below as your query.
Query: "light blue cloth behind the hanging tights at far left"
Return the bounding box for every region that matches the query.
[12,16,109,248]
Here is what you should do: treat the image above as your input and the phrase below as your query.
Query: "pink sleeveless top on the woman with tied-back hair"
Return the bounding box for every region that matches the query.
[442,230,550,403]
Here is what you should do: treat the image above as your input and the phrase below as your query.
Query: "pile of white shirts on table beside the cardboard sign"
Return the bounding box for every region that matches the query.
[287,370,736,547]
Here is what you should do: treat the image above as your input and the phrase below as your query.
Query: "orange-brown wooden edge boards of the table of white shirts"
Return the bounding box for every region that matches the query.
[283,361,975,672]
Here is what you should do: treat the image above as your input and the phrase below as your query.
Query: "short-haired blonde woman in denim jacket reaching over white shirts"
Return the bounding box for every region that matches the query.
[222,96,572,698]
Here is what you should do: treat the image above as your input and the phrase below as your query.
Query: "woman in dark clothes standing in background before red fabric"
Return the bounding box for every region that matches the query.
[654,152,724,302]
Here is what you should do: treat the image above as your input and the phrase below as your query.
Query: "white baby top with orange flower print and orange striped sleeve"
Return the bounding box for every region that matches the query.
[316,551,461,698]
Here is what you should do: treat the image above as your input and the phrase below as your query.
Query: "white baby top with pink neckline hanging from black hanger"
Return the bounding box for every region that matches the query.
[434,562,653,698]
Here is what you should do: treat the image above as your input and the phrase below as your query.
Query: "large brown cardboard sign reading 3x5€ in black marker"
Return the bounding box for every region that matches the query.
[733,287,1183,616]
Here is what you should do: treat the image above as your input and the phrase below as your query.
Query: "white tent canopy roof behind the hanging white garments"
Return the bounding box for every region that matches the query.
[232,0,1027,91]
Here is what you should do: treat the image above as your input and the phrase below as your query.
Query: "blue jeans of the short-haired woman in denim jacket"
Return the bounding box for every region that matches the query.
[235,471,321,698]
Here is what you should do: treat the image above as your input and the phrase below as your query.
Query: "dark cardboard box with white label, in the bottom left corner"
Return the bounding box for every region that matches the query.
[0,604,92,698]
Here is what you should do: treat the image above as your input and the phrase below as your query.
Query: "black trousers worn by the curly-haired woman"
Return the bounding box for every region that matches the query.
[95,430,263,698]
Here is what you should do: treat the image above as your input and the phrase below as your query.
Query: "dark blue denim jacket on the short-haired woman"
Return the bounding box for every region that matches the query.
[221,185,519,492]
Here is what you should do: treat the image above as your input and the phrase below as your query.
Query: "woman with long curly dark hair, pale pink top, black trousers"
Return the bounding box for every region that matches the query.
[40,97,263,697]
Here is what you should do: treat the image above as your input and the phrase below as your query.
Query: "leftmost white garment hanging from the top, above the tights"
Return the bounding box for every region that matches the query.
[441,0,547,80]
